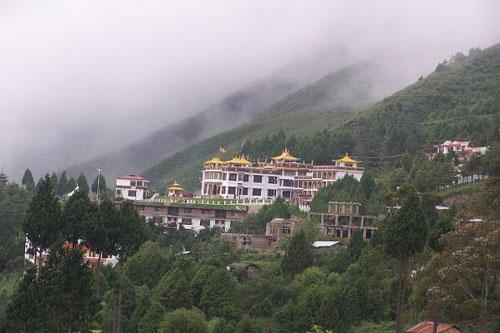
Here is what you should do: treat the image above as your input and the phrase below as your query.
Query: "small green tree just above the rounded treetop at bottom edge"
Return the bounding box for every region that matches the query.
[154,268,192,310]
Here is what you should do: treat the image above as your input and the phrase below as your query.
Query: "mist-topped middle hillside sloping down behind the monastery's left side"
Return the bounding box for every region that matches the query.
[144,63,387,190]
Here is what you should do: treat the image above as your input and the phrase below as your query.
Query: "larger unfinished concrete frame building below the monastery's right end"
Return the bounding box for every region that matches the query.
[308,202,384,240]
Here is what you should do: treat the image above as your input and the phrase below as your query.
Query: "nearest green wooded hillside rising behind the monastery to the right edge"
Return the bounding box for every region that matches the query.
[237,45,500,166]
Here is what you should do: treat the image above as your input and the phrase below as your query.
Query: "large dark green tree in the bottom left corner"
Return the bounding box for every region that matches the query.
[2,245,97,332]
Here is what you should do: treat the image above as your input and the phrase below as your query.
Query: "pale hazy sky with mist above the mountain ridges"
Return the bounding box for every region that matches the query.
[0,0,500,176]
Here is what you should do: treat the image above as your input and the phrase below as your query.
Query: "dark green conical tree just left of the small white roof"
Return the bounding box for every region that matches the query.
[281,230,313,277]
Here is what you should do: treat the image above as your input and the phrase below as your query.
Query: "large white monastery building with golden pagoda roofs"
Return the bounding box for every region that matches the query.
[201,149,364,204]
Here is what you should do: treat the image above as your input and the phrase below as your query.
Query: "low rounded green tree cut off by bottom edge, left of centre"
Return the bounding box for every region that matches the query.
[159,308,208,333]
